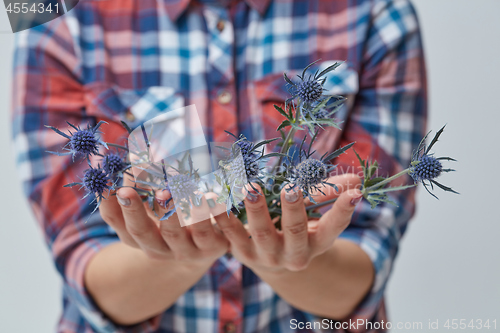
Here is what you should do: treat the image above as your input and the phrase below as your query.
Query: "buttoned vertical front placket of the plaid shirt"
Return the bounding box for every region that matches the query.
[204,5,243,333]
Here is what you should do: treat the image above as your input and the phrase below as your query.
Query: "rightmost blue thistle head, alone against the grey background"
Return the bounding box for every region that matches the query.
[408,125,458,199]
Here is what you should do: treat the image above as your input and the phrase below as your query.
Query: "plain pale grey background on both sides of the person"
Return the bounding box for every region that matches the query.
[0,0,500,333]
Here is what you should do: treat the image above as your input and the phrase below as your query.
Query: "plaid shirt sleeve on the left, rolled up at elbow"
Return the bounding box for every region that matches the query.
[12,15,158,332]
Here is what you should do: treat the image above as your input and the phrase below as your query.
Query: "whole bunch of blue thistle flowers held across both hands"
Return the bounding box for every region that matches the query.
[47,63,457,223]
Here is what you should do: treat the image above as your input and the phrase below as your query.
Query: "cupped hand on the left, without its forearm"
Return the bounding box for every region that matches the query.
[99,174,229,265]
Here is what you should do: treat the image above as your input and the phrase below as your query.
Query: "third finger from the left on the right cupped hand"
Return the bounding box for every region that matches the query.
[281,188,308,255]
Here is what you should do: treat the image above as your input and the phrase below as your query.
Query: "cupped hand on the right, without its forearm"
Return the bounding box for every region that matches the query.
[212,174,362,273]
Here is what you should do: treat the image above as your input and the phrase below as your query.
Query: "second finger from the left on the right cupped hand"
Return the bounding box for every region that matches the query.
[245,184,281,253]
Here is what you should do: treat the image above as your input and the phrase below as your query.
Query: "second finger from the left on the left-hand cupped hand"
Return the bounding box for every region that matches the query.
[117,188,169,257]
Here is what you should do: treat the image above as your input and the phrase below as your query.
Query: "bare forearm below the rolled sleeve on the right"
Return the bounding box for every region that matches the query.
[255,239,374,320]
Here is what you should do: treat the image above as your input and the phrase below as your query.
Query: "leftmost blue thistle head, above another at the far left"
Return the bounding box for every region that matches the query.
[45,121,108,166]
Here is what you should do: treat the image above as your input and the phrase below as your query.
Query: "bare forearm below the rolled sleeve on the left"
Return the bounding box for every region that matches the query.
[85,242,212,325]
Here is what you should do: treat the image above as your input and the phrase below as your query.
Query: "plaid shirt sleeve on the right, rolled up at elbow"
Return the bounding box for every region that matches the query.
[337,0,427,320]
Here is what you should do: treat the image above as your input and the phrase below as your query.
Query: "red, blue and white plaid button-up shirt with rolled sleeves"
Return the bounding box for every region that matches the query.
[12,0,426,333]
